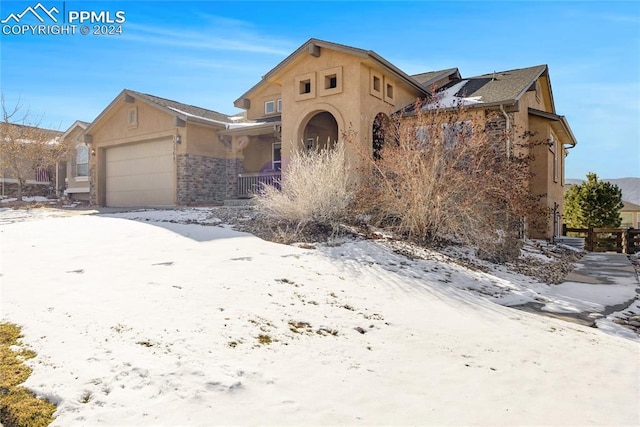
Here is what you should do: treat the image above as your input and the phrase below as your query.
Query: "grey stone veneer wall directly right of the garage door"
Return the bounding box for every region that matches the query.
[177,154,242,205]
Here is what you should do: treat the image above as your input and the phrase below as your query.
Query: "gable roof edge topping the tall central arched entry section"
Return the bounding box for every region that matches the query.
[234,38,429,108]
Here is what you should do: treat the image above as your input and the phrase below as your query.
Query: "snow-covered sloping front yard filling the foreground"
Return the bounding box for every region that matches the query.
[0,209,640,426]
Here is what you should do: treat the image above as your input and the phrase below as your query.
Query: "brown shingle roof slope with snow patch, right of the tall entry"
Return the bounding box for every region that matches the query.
[442,65,547,104]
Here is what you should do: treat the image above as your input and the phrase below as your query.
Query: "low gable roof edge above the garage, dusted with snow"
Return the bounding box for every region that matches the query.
[86,89,233,133]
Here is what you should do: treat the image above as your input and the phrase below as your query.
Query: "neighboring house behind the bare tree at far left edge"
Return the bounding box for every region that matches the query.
[0,123,64,197]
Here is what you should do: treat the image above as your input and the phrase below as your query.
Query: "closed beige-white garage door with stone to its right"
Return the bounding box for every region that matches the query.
[106,139,176,207]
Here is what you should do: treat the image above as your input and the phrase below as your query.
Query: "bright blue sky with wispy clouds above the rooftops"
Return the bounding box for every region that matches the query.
[0,0,640,178]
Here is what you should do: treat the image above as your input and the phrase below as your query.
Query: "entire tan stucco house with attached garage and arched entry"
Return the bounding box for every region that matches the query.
[65,39,576,238]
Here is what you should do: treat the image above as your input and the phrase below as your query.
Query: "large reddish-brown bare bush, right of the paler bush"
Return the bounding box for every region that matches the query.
[356,98,543,262]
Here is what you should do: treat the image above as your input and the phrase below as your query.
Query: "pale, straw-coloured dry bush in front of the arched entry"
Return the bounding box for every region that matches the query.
[256,141,354,241]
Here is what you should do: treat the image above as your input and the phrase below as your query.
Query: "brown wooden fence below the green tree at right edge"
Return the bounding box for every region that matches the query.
[562,224,640,254]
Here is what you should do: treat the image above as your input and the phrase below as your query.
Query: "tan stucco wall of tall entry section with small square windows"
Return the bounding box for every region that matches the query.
[249,48,419,168]
